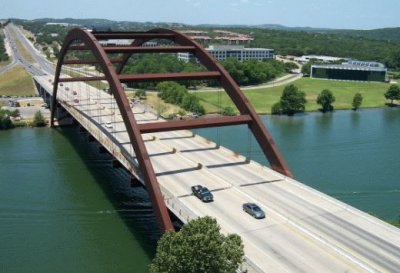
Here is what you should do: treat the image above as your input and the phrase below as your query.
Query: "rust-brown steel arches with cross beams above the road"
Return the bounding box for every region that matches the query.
[50,28,292,232]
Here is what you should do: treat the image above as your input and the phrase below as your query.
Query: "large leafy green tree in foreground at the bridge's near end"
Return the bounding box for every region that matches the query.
[150,216,244,273]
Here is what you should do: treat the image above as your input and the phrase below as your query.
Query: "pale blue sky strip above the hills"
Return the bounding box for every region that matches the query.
[0,0,400,29]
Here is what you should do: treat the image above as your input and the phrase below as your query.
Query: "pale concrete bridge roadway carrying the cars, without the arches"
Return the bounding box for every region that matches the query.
[35,77,400,272]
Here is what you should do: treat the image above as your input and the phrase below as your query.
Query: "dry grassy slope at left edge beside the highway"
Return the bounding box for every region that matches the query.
[0,66,35,96]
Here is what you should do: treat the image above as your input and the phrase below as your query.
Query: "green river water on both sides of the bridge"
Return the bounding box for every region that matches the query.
[0,108,400,272]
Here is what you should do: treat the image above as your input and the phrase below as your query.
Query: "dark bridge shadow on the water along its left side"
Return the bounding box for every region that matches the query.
[56,126,160,258]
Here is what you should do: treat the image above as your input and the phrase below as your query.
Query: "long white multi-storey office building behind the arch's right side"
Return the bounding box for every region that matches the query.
[178,45,274,62]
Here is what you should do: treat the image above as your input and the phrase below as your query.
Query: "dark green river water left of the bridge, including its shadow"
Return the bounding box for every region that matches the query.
[0,128,158,273]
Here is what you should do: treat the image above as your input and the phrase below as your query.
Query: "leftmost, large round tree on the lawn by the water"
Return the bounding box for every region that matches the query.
[280,84,307,116]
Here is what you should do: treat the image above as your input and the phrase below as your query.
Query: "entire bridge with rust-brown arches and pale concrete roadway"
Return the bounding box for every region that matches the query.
[21,26,400,272]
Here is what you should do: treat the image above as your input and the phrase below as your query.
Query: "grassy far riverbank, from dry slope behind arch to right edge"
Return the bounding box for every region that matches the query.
[127,78,400,119]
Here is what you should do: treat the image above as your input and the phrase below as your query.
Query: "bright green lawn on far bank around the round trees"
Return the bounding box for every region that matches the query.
[196,78,389,114]
